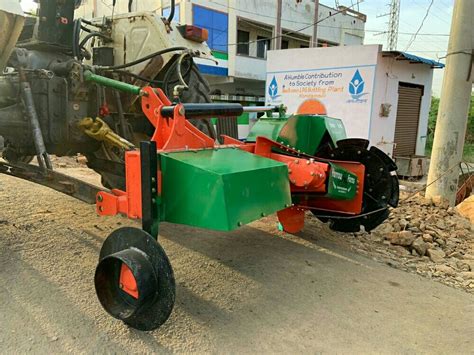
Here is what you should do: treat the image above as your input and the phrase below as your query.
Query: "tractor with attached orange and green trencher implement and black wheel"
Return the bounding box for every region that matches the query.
[0,0,399,331]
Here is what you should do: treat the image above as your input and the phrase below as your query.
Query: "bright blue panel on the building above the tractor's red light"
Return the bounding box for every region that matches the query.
[193,5,229,53]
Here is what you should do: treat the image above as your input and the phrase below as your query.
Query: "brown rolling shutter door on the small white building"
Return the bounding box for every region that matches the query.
[393,83,423,156]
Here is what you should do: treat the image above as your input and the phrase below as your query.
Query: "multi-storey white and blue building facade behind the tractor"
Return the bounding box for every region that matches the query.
[77,0,365,104]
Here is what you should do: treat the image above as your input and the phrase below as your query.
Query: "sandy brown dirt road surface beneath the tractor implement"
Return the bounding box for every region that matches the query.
[0,164,474,354]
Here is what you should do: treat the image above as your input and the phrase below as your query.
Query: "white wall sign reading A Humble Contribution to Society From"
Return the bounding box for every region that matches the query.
[266,46,379,138]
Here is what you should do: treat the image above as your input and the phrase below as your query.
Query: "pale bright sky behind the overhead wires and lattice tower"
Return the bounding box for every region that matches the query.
[22,0,454,97]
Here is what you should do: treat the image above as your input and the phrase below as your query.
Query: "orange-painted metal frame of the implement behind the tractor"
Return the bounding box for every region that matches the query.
[96,87,365,236]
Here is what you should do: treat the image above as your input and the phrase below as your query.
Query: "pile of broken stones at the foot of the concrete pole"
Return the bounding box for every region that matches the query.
[356,195,474,292]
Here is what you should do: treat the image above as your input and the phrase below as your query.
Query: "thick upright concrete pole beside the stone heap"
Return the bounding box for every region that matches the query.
[426,0,474,205]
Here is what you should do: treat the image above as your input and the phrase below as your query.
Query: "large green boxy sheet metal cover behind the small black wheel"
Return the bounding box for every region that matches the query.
[161,148,291,231]
